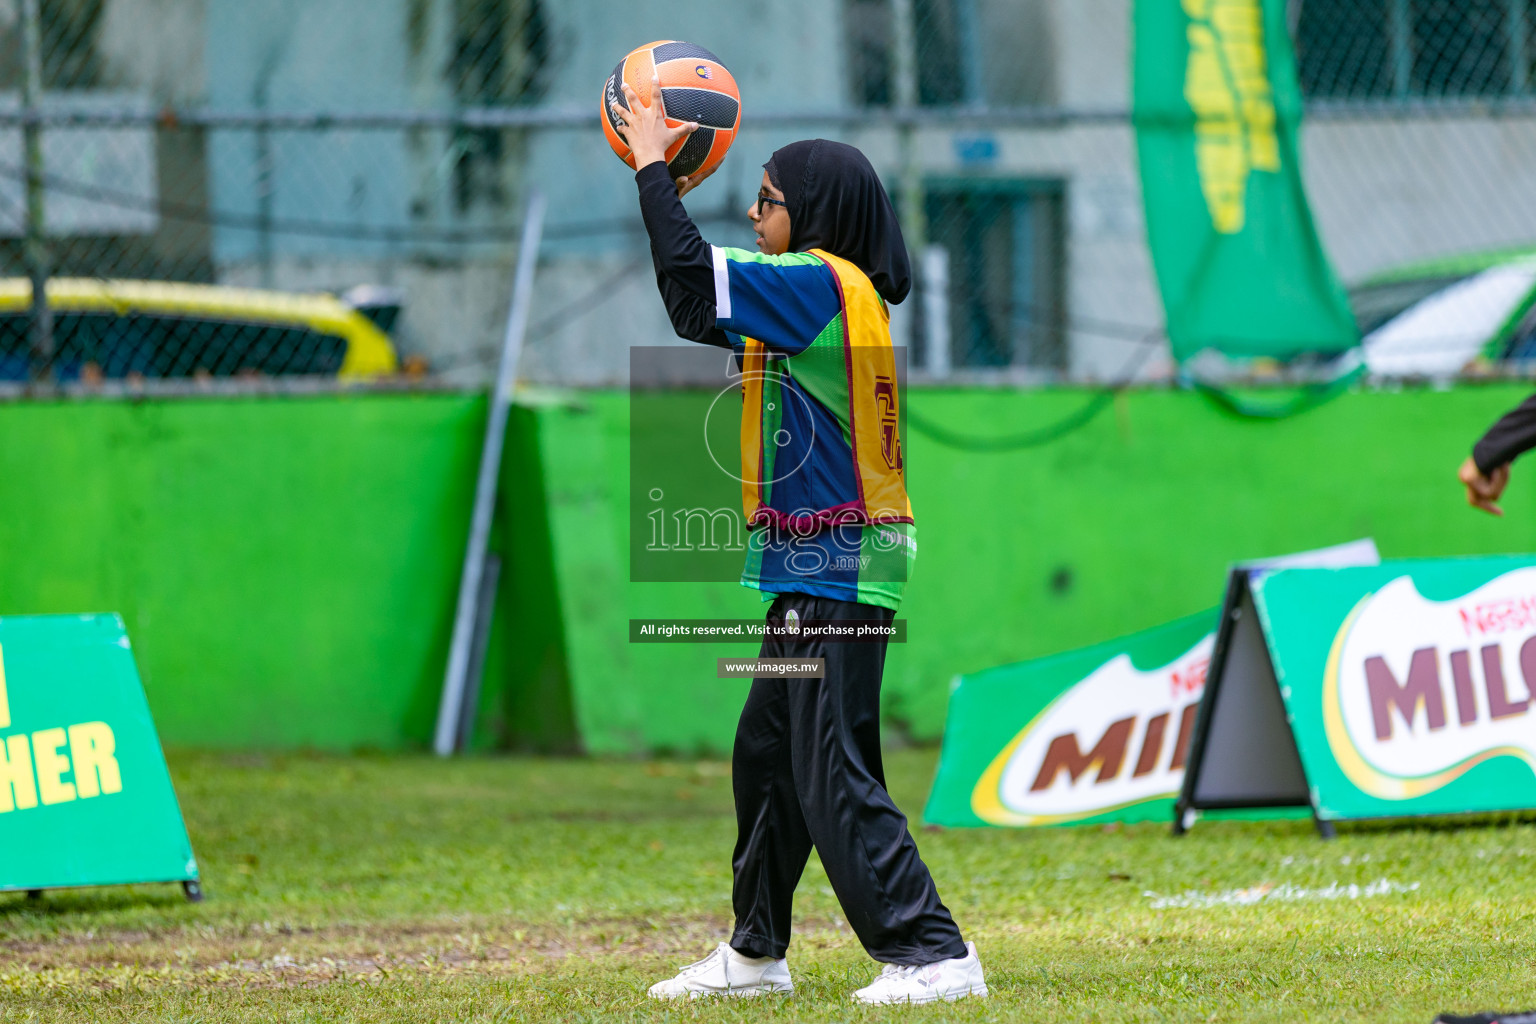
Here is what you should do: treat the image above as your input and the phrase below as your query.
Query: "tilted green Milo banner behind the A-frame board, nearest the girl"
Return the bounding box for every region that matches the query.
[923,609,1217,826]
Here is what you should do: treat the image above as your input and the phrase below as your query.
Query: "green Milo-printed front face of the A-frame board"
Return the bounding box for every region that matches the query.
[1256,557,1536,820]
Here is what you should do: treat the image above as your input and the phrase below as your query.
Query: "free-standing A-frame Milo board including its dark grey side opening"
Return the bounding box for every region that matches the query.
[1175,556,1536,834]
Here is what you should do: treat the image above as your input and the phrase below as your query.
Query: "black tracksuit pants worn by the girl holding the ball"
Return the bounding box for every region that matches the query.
[731,594,966,964]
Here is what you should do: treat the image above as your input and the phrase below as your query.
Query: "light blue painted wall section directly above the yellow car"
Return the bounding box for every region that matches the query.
[204,0,452,267]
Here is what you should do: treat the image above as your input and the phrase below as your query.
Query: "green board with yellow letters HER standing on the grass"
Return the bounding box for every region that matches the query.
[0,616,200,897]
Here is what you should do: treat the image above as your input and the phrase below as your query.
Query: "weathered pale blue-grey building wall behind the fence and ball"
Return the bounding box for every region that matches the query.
[196,0,846,385]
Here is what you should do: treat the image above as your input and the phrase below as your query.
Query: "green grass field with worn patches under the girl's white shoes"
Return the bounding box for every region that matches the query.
[0,751,1536,1024]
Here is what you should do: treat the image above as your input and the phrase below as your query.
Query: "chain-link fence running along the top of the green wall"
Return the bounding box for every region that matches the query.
[0,0,1536,388]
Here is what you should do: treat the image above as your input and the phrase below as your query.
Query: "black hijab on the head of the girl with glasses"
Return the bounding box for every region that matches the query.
[763,138,912,302]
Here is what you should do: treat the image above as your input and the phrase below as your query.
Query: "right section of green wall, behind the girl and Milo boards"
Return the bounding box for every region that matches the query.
[539,385,1536,752]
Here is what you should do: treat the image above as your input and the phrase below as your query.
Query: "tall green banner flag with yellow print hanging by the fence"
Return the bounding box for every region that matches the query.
[1132,0,1358,361]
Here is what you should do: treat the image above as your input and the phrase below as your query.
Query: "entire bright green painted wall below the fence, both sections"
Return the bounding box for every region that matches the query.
[0,385,1536,752]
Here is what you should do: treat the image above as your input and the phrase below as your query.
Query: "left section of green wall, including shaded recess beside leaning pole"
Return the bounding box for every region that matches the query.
[0,393,570,749]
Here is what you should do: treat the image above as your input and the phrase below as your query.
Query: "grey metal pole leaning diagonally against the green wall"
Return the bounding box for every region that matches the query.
[432,189,544,757]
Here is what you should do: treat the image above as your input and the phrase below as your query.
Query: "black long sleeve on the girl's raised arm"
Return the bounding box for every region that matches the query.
[634,161,731,348]
